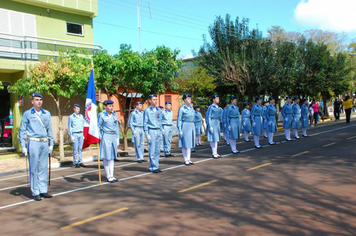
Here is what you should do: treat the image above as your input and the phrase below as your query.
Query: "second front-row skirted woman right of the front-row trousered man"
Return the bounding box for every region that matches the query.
[205,94,221,159]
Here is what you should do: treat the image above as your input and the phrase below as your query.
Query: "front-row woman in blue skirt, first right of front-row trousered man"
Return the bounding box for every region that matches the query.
[177,94,195,166]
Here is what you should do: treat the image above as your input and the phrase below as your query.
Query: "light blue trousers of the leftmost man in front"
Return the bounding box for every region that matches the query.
[27,140,49,196]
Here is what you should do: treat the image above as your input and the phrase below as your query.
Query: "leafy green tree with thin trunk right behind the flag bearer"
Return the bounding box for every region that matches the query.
[94,45,181,150]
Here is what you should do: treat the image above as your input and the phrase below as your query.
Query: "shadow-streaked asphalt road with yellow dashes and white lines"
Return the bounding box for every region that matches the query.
[0,122,356,236]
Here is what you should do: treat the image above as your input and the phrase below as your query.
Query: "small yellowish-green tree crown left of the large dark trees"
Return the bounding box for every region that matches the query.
[175,66,217,101]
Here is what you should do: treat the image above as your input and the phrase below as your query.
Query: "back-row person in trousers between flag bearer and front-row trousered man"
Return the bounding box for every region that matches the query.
[129,102,145,163]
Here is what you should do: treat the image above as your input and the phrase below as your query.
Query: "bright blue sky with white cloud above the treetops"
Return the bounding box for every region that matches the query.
[94,0,356,58]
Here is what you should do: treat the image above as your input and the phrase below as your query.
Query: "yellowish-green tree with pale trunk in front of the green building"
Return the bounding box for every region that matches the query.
[9,51,91,161]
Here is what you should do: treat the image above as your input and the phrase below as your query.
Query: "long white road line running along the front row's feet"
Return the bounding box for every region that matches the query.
[0,124,356,210]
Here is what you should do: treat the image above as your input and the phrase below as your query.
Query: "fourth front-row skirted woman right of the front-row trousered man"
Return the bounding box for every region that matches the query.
[251,96,263,149]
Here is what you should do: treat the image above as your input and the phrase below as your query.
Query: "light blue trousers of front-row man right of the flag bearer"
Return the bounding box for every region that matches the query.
[148,129,162,171]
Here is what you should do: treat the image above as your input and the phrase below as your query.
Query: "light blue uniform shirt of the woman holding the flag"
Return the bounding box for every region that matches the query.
[98,111,120,137]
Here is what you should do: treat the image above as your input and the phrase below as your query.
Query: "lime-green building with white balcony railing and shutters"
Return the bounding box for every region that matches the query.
[0,0,101,151]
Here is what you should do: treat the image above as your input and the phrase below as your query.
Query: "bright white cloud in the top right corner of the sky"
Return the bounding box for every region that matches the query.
[294,0,356,32]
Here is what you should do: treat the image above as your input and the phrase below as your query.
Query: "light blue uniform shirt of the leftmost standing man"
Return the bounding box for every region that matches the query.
[19,108,53,148]
